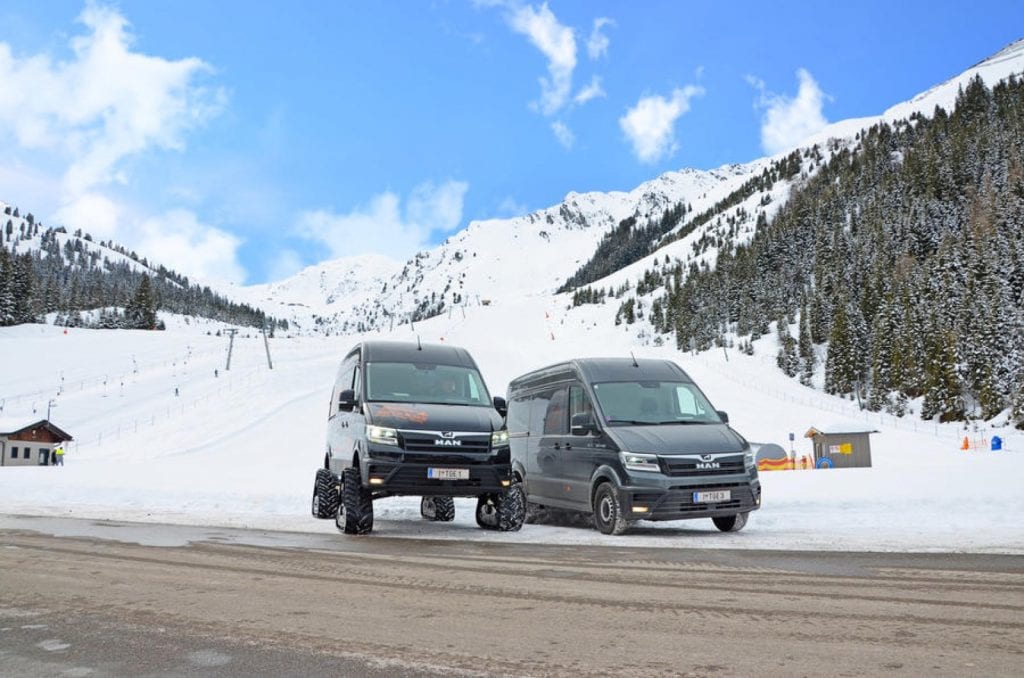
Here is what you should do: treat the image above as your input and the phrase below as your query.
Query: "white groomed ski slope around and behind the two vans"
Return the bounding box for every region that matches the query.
[0,305,1024,554]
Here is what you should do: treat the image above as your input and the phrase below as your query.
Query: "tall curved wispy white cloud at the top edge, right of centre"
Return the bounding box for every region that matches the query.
[508,3,577,116]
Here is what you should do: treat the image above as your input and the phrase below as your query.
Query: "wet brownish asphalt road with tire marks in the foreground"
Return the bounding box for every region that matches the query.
[0,516,1024,676]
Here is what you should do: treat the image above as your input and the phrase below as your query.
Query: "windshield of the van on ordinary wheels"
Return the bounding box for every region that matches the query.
[594,381,722,426]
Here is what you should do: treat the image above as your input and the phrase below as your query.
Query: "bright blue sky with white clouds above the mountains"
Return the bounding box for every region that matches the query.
[0,0,1024,283]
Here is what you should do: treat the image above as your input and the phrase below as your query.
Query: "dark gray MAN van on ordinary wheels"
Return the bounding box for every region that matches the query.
[507,357,761,535]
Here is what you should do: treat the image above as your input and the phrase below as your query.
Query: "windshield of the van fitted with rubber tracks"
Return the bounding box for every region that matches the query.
[367,363,490,407]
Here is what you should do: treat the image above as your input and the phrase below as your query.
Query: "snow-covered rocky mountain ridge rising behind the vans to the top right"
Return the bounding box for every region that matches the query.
[243,40,1024,334]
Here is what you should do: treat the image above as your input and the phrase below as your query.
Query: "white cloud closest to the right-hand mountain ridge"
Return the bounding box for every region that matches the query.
[746,69,828,156]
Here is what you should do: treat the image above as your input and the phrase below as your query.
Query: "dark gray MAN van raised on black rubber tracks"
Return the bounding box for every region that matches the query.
[312,341,524,535]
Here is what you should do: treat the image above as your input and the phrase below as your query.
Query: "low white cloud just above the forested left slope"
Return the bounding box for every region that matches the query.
[138,210,246,285]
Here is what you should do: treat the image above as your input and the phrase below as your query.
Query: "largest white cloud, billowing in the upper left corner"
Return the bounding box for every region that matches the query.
[0,2,226,262]
